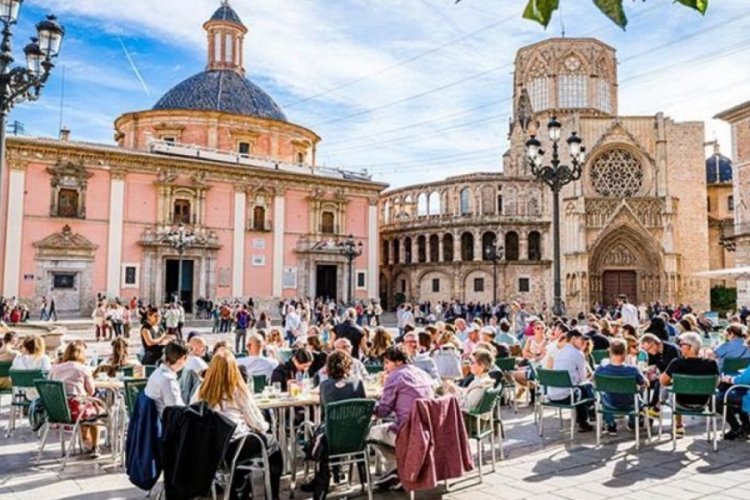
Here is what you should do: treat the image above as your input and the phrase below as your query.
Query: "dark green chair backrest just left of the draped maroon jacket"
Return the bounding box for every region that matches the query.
[325,399,375,455]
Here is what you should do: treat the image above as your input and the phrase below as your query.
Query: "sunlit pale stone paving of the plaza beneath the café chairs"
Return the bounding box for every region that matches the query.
[0,326,750,500]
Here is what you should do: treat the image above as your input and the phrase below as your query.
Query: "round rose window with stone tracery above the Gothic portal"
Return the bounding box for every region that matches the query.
[591,149,643,198]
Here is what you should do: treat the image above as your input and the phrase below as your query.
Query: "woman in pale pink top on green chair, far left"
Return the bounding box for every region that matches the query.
[49,340,105,458]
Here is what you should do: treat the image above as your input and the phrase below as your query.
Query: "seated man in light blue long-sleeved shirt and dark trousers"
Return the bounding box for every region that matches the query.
[547,330,594,432]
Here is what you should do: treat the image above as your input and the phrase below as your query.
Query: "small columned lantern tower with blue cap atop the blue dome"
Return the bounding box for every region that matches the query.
[203,0,247,76]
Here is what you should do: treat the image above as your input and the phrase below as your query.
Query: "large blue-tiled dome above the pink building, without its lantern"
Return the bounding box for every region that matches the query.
[153,70,286,121]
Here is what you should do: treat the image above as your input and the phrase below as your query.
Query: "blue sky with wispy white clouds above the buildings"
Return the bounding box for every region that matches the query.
[10,0,750,186]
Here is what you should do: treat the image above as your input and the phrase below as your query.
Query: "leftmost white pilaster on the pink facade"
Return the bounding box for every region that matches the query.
[2,161,27,297]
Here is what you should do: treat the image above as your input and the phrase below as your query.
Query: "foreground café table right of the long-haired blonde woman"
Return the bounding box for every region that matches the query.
[255,384,383,473]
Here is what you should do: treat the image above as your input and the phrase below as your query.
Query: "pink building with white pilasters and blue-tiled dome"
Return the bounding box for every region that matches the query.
[0,4,385,315]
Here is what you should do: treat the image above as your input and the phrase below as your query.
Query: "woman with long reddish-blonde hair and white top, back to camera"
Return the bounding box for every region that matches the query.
[191,349,283,499]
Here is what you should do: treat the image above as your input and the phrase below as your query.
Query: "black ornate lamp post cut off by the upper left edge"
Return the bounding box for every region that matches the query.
[0,0,65,209]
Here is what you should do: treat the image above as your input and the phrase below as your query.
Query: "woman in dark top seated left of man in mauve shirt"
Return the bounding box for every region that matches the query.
[301,351,365,499]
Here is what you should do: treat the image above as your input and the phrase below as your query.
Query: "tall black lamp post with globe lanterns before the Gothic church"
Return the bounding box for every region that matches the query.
[526,116,586,316]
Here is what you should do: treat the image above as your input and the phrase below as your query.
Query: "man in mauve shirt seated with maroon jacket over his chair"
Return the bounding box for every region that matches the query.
[368,346,433,488]
